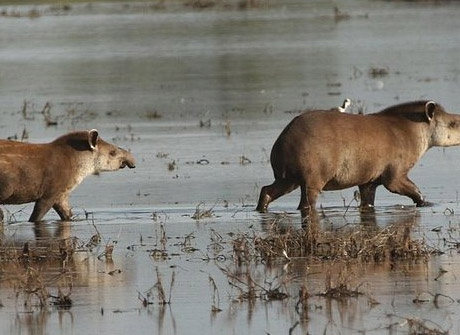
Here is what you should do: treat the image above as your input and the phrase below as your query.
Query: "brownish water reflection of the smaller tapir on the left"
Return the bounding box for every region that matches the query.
[0,221,129,334]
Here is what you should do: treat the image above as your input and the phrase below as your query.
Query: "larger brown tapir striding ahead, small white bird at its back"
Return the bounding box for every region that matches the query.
[257,101,460,213]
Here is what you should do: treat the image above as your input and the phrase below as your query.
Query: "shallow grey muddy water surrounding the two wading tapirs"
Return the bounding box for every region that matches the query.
[0,1,460,334]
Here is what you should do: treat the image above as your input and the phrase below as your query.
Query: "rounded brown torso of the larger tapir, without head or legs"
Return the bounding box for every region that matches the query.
[271,110,426,182]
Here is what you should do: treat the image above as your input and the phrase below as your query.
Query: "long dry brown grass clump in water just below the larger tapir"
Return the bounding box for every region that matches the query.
[233,222,432,263]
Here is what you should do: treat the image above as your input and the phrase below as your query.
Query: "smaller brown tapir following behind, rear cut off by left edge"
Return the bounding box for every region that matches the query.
[0,129,135,222]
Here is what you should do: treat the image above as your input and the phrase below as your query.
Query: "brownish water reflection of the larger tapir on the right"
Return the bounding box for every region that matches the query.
[255,206,434,334]
